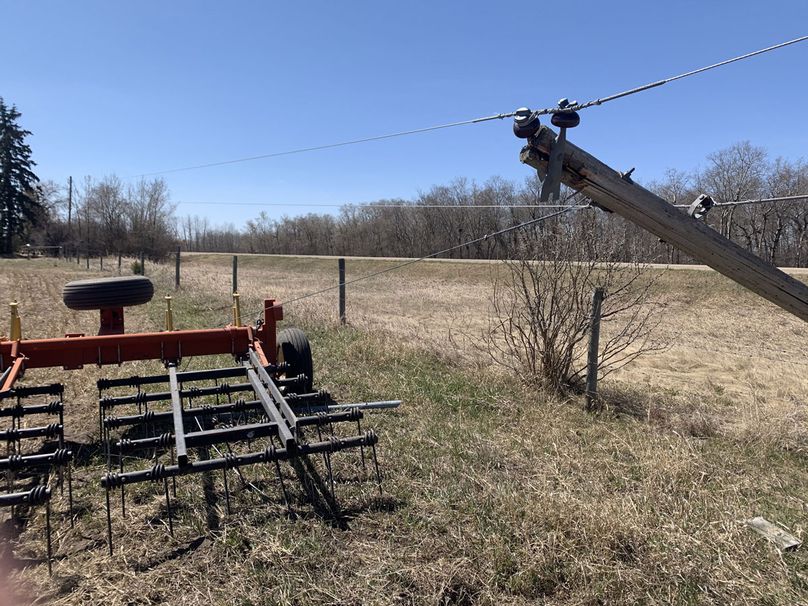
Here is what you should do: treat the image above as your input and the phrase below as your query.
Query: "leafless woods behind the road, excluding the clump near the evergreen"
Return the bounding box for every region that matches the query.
[177,142,808,266]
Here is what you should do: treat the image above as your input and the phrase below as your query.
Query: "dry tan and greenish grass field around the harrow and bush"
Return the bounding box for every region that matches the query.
[0,255,808,606]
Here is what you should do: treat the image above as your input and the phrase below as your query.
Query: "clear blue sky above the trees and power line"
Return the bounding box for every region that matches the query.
[0,0,808,225]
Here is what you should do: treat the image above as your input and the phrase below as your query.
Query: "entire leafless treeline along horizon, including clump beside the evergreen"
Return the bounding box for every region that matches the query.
[30,142,808,266]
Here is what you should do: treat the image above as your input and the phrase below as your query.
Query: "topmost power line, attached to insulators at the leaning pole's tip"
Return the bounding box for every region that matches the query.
[135,36,808,177]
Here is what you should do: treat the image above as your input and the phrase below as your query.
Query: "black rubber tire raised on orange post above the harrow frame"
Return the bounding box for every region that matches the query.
[62,276,154,311]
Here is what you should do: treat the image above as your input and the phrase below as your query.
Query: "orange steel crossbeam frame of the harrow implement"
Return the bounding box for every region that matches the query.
[0,299,283,392]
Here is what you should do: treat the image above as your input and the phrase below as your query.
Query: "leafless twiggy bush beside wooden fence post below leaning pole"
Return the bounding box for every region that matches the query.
[482,215,664,391]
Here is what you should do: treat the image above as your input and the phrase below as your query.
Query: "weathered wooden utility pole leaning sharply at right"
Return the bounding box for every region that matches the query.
[520,125,808,322]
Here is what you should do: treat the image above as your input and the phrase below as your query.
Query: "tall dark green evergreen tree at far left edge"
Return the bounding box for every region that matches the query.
[0,97,44,255]
